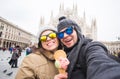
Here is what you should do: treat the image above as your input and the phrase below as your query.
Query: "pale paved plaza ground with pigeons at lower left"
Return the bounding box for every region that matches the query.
[0,50,26,79]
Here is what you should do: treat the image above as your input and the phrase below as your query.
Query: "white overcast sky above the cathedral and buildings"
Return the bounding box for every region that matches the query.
[0,0,120,41]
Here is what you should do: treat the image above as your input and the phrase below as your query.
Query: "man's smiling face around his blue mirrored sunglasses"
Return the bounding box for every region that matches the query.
[60,28,77,48]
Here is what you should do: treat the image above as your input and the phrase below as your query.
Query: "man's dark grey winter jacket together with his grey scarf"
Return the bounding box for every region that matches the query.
[65,27,120,79]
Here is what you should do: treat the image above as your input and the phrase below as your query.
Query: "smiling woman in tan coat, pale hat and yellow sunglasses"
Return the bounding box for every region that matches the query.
[15,27,62,79]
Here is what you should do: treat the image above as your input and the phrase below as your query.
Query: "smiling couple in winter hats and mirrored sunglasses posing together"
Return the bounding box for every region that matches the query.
[15,17,120,79]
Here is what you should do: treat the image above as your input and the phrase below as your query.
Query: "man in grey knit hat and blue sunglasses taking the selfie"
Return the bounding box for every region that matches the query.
[54,17,120,79]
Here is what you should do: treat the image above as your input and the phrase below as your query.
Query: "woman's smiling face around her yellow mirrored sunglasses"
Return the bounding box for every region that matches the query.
[41,30,59,51]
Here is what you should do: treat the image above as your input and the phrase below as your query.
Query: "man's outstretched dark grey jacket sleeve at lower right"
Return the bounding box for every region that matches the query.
[86,45,120,79]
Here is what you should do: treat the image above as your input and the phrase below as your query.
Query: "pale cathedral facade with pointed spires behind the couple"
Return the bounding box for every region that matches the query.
[39,4,97,40]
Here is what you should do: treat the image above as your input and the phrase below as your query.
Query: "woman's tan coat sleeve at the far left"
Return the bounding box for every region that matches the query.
[15,57,35,79]
